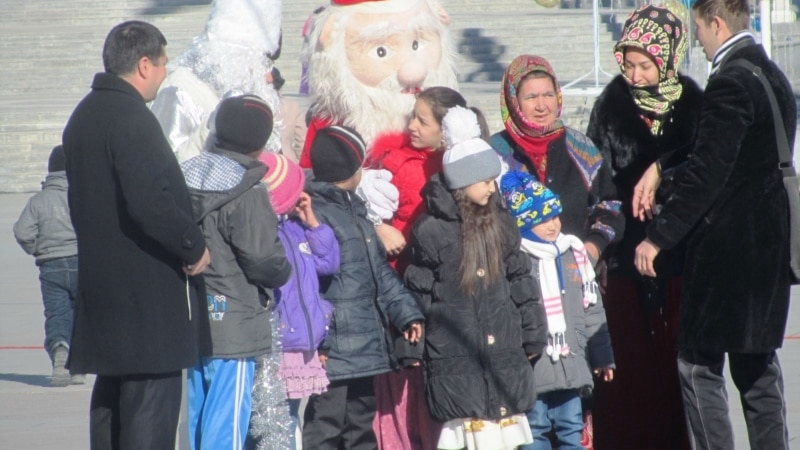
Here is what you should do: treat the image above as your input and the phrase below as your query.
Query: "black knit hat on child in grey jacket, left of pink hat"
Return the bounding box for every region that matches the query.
[214,95,272,154]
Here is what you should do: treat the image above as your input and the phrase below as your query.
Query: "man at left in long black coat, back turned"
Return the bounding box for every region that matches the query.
[63,21,210,449]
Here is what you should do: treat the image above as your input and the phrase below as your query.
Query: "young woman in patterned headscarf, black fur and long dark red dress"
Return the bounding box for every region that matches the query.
[587,6,702,450]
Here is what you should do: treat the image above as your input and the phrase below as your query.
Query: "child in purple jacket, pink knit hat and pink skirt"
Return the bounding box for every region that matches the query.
[252,153,339,448]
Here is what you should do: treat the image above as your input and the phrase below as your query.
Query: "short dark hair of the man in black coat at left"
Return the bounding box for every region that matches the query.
[103,20,167,75]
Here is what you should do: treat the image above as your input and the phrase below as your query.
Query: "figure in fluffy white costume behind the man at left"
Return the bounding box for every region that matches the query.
[150,0,282,162]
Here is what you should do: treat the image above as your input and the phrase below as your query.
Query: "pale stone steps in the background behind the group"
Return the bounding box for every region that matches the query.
[0,0,618,192]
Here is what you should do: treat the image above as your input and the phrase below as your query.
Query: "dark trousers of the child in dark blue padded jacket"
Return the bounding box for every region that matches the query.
[303,377,378,450]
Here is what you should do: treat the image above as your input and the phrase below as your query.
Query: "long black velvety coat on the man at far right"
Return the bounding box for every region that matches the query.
[647,38,797,353]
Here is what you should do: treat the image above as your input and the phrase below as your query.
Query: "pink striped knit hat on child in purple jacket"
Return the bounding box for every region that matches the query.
[258,152,306,215]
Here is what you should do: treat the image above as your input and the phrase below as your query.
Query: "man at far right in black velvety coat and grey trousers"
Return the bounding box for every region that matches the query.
[633,0,796,449]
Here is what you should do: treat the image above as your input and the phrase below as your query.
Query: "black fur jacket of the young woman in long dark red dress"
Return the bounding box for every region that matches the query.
[586,75,703,279]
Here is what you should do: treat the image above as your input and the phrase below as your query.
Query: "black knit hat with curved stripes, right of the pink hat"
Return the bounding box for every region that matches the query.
[311,126,366,183]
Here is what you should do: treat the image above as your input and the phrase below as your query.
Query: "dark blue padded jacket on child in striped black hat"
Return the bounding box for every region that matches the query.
[309,182,423,381]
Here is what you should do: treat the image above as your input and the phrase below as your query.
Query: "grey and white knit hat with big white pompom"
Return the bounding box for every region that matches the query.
[442,106,500,190]
